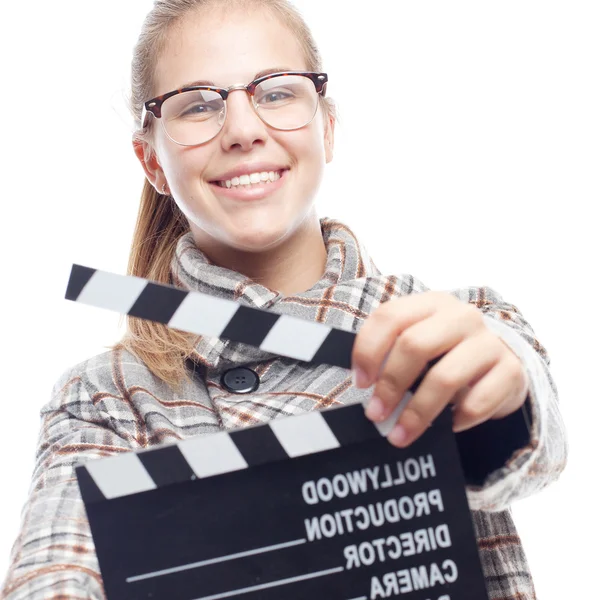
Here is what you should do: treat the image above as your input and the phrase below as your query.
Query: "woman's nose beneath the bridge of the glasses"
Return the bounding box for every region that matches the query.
[221,89,268,152]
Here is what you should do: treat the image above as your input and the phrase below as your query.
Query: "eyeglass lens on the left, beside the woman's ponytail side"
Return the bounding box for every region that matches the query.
[161,90,225,146]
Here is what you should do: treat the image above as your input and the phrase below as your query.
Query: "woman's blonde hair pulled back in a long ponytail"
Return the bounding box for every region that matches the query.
[117,0,336,388]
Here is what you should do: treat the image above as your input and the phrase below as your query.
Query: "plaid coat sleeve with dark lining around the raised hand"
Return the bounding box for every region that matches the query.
[453,288,568,511]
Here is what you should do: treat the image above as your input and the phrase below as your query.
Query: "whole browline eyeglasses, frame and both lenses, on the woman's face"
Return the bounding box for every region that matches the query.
[141,71,327,146]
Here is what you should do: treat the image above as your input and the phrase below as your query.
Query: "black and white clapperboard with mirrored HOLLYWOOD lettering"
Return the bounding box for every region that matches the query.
[66,265,488,600]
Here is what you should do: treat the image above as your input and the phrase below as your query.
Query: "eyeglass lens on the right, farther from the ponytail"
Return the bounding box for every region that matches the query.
[254,75,318,130]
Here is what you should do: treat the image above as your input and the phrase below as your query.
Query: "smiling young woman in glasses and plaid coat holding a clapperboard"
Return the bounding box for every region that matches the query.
[3,0,566,600]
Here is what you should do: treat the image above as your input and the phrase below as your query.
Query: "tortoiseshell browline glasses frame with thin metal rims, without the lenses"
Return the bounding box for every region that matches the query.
[140,71,328,146]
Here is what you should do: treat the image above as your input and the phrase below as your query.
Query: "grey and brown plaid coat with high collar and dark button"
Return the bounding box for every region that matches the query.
[2,219,567,600]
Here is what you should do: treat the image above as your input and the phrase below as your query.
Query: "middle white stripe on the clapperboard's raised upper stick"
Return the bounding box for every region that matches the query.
[169,292,240,337]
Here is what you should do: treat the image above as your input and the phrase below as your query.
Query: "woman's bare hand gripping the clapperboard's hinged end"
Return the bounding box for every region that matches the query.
[352,292,529,447]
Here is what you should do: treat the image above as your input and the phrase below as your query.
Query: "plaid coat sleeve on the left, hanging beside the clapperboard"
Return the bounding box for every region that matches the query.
[0,372,132,600]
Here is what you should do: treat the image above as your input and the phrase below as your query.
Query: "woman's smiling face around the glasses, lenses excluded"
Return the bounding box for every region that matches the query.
[136,11,334,256]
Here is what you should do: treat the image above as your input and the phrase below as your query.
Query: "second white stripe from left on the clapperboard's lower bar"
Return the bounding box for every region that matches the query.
[177,431,248,477]
